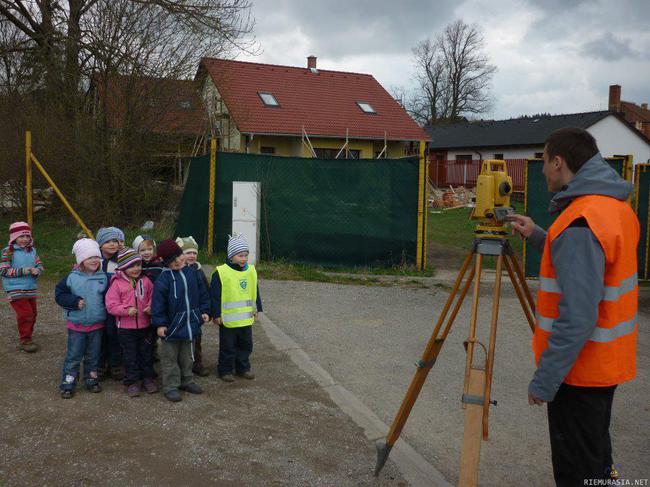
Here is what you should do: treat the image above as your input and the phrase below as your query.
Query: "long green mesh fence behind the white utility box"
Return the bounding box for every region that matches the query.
[176,152,419,266]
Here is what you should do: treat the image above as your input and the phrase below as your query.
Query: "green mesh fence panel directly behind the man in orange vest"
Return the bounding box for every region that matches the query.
[524,157,625,277]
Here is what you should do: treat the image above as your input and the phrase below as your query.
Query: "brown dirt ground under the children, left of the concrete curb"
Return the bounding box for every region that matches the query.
[0,284,407,486]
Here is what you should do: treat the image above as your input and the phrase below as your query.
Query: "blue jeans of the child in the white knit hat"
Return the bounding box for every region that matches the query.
[60,328,104,391]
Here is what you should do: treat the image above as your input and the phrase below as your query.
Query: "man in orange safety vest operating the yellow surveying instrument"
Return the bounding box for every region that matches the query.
[510,128,639,486]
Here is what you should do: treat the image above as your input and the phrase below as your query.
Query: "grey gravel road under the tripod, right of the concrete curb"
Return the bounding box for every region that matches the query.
[261,280,650,486]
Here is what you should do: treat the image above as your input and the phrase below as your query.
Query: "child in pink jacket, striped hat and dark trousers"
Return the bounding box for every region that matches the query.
[106,248,158,397]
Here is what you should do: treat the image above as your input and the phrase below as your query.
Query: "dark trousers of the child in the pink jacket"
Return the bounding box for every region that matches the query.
[117,327,153,386]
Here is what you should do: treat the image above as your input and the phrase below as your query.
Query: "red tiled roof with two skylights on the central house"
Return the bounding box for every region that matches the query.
[197,58,429,140]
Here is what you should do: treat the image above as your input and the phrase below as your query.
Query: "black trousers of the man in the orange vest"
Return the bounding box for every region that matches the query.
[548,384,616,487]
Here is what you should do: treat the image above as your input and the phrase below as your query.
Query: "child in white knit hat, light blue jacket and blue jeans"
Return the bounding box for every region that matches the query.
[54,238,108,399]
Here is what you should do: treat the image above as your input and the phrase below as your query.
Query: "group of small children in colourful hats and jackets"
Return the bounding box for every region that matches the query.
[0,222,262,402]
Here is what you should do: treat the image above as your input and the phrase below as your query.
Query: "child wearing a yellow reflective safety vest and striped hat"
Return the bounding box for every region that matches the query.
[210,235,262,382]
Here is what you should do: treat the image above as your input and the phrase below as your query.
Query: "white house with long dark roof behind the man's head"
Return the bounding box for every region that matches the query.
[426,111,650,164]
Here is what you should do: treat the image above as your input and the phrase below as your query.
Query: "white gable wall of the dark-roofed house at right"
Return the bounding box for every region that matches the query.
[587,115,650,164]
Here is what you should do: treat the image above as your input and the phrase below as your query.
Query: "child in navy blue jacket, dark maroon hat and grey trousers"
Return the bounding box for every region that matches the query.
[151,240,210,402]
